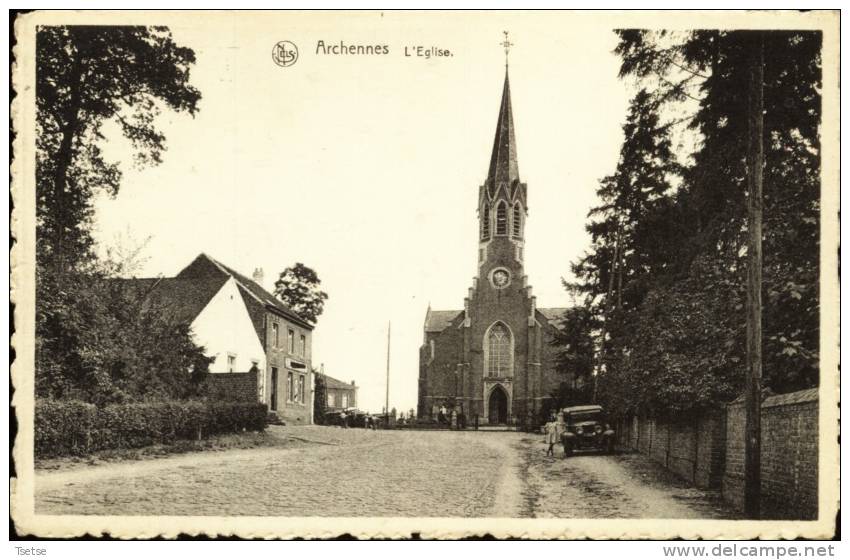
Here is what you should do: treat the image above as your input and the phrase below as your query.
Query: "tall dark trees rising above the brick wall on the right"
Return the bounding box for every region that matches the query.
[569,30,821,413]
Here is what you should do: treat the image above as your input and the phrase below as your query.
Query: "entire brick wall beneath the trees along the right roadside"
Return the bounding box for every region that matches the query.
[617,389,818,519]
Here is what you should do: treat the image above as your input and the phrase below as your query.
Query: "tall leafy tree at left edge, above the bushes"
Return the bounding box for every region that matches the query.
[36,26,201,274]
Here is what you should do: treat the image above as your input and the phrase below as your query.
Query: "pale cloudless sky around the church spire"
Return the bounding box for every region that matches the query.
[95,12,629,411]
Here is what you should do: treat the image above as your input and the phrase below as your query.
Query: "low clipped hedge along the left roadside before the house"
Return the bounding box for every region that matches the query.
[35,400,268,458]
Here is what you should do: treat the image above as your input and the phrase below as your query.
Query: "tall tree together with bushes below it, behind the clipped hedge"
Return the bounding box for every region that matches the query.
[36,26,210,404]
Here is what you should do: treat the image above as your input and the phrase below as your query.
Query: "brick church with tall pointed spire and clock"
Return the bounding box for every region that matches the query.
[418,67,571,424]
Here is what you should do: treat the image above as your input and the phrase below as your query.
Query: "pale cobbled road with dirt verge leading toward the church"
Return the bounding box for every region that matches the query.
[35,426,730,518]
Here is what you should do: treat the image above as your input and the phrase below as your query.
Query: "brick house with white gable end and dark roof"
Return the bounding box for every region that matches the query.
[125,254,313,424]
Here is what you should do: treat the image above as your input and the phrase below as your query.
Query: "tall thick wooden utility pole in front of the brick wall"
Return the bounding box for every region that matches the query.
[744,31,764,519]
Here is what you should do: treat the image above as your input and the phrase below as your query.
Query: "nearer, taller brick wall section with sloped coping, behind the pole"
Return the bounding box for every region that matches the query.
[723,389,818,519]
